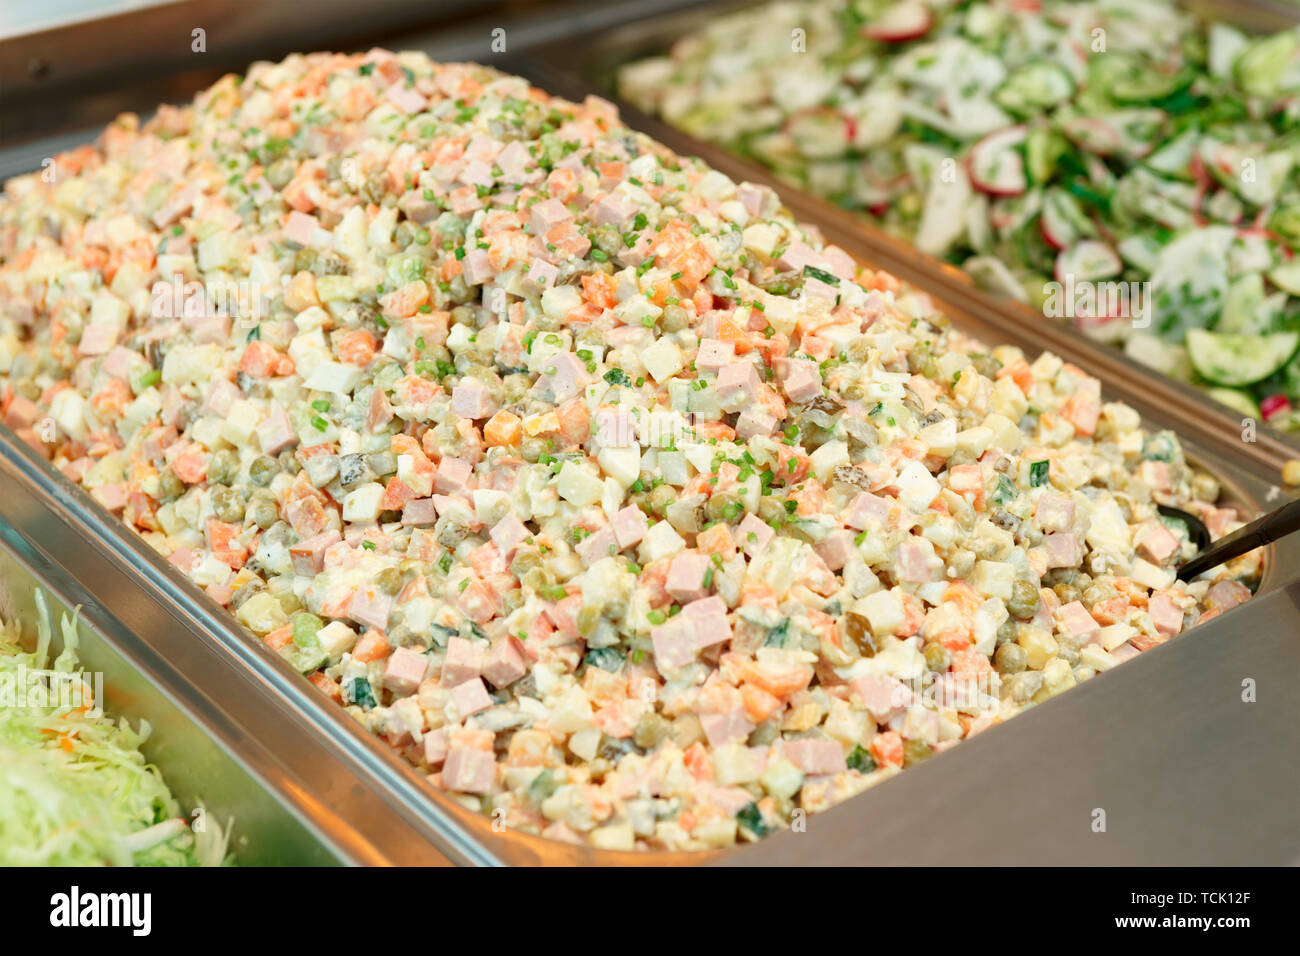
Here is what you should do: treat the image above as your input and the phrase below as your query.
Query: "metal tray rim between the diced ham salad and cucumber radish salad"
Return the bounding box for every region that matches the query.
[511,0,1300,481]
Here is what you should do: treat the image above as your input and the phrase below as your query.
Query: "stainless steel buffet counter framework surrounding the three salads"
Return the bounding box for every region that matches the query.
[0,1,1300,866]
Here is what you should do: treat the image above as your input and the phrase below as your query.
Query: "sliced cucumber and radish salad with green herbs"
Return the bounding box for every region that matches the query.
[619,0,1300,431]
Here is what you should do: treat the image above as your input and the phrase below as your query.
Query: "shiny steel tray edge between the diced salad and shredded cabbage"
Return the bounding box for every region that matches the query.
[0,433,480,865]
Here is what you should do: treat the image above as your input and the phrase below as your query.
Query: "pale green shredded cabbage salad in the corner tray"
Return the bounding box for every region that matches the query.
[0,591,228,866]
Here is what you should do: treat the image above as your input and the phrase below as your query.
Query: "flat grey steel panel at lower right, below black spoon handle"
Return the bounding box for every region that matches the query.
[728,584,1300,866]
